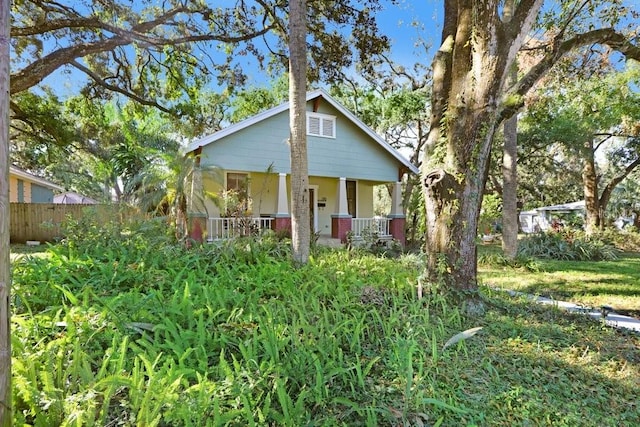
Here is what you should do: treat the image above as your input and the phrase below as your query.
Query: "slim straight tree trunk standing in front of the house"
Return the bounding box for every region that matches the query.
[289,0,311,264]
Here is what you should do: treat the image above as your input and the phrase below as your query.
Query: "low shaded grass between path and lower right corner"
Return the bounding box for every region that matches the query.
[438,292,640,426]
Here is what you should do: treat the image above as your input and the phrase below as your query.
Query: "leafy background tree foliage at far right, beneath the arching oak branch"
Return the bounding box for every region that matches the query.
[518,58,640,212]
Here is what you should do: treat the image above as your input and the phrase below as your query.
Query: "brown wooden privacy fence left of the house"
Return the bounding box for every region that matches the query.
[9,203,133,243]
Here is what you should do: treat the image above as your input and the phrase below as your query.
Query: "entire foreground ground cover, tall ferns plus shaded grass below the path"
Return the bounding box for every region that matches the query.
[12,225,640,426]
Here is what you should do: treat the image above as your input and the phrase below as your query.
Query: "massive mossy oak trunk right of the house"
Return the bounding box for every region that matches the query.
[422,0,542,311]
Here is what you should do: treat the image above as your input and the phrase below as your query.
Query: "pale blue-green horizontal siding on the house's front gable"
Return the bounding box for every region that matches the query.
[202,102,399,182]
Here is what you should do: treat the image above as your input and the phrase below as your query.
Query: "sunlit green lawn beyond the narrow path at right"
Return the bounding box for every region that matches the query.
[478,247,640,313]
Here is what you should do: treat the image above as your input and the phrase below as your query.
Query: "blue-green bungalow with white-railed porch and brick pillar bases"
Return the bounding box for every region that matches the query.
[187,89,418,242]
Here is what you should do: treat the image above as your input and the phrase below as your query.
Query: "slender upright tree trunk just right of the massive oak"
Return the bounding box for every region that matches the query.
[502,0,518,259]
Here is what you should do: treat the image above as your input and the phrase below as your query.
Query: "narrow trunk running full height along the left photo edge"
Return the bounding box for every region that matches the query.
[0,0,13,426]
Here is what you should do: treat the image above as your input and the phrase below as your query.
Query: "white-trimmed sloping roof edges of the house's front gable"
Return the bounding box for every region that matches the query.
[186,89,420,174]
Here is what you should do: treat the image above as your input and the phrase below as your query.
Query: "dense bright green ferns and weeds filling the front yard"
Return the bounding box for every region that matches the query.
[13,223,492,426]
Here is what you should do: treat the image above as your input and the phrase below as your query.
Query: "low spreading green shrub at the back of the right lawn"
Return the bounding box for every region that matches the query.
[518,231,619,261]
